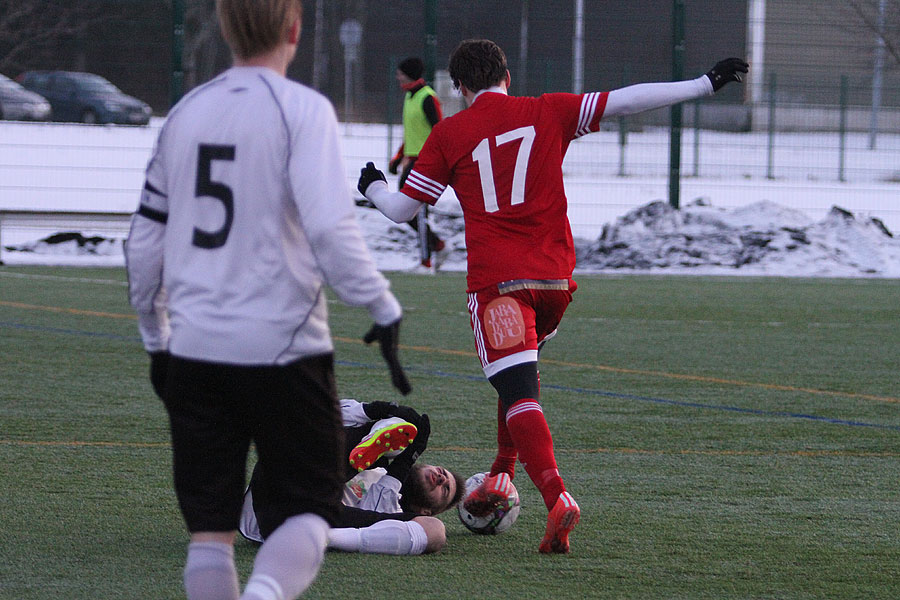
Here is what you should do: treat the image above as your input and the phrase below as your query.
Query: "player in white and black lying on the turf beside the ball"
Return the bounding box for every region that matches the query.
[240,399,465,555]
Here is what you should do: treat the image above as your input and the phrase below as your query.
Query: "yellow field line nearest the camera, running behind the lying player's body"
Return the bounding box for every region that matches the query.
[0,440,900,458]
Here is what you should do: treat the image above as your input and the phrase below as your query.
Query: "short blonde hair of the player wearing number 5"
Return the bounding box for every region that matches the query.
[216,0,303,59]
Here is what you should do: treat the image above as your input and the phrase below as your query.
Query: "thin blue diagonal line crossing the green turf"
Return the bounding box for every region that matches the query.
[0,321,900,431]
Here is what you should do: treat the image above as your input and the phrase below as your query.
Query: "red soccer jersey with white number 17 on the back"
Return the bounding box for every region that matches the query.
[401,92,607,291]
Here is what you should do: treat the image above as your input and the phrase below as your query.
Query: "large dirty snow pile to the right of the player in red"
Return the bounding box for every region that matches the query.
[578,200,900,277]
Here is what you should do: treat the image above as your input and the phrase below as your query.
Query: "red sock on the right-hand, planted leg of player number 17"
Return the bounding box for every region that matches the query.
[506,398,566,510]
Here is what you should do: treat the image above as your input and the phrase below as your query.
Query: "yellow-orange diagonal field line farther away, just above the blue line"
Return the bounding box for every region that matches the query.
[0,300,900,404]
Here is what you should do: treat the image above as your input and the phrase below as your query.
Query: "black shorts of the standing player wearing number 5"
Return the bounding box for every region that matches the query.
[165,354,347,533]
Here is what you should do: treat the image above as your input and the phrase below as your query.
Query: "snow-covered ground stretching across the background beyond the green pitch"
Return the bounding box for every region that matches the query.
[0,123,900,278]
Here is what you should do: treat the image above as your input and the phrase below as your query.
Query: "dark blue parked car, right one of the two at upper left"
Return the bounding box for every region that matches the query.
[18,71,152,125]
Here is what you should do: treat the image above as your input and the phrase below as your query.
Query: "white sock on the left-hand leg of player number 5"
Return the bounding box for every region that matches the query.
[184,542,241,600]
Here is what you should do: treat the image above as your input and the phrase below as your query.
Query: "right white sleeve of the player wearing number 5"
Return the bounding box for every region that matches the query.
[290,98,402,325]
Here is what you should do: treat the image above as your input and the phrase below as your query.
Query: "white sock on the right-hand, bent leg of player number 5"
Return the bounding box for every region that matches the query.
[241,513,328,600]
